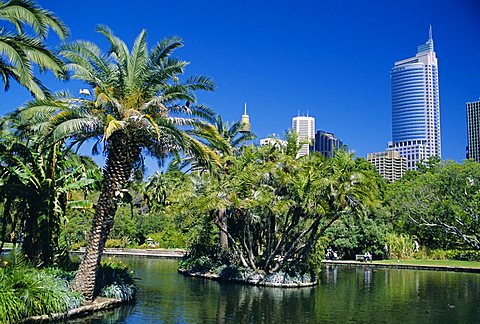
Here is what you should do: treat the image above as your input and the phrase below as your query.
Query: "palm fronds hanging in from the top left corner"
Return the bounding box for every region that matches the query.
[0,0,68,98]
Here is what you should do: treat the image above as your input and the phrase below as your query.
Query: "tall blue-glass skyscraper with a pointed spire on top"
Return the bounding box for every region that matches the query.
[389,26,442,170]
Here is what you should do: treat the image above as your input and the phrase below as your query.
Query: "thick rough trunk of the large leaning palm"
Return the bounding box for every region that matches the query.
[72,132,140,301]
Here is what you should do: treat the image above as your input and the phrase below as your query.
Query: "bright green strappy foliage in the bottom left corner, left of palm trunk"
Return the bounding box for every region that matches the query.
[0,250,83,323]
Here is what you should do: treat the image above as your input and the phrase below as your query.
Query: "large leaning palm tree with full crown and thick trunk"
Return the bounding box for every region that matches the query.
[15,26,217,300]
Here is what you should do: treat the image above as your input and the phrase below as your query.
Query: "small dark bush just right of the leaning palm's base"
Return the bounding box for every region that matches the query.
[96,258,136,301]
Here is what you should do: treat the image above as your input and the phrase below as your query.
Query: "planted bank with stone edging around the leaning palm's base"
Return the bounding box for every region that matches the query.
[0,249,137,323]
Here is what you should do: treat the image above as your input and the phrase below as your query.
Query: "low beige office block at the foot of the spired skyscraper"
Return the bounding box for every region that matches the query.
[367,150,407,181]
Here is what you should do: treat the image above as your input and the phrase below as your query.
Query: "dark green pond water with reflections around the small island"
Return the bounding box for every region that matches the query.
[72,257,480,324]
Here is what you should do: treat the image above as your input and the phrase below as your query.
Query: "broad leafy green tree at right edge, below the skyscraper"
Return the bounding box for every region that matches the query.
[387,159,480,249]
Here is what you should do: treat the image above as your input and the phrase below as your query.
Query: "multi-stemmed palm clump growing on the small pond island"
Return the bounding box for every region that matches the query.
[174,146,378,274]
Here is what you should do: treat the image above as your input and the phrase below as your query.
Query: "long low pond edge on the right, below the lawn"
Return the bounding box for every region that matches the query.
[323,260,480,273]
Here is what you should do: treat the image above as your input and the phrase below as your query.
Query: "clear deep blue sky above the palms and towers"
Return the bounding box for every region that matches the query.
[0,0,480,166]
